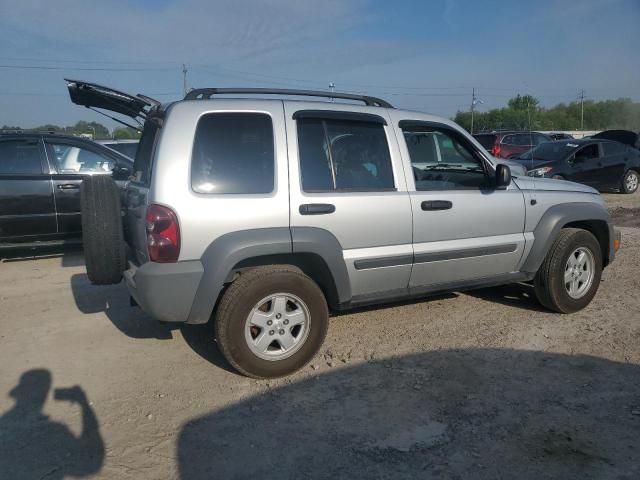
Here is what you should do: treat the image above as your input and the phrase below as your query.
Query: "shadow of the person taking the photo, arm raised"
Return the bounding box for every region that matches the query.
[0,369,105,479]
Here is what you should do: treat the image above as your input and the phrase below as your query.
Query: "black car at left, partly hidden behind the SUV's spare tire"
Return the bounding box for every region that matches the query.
[0,133,133,248]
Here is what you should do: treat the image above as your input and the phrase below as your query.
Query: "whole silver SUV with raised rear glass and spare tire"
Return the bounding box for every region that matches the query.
[68,80,620,378]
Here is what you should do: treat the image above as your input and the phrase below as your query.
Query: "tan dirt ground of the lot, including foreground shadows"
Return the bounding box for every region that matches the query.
[0,194,640,479]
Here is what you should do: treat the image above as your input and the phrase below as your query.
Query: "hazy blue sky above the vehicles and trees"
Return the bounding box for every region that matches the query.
[0,0,640,128]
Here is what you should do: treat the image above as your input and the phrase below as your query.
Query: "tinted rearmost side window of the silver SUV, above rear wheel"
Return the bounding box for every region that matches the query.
[191,112,275,194]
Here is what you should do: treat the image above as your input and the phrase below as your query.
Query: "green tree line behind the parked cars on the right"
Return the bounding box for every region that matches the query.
[453,95,640,132]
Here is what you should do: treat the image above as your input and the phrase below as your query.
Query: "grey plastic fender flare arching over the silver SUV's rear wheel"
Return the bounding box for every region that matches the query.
[187,227,351,323]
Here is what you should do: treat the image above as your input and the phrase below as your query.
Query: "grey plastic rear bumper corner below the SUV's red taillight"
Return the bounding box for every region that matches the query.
[124,260,204,322]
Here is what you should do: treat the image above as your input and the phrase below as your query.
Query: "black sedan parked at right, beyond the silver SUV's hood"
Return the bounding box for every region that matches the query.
[514,138,640,193]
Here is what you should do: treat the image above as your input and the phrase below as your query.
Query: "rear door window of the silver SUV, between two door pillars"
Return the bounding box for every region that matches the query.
[297,118,395,192]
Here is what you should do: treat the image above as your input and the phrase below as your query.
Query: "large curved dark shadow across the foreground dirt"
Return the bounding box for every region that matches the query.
[178,349,640,480]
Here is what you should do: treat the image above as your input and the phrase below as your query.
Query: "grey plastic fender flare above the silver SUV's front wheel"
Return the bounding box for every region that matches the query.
[520,202,615,273]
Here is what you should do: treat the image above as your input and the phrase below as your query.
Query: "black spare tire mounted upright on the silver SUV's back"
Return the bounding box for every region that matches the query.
[80,175,126,285]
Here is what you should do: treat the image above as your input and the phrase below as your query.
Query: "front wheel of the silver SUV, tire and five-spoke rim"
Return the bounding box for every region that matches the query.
[534,228,602,313]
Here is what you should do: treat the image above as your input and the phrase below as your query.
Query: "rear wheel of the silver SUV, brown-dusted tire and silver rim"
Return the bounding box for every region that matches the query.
[215,265,329,378]
